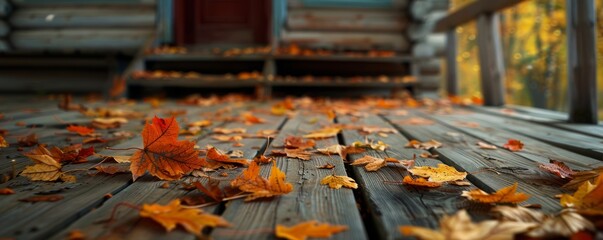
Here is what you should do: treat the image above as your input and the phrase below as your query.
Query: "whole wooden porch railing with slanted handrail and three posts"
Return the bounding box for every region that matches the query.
[434,0,598,124]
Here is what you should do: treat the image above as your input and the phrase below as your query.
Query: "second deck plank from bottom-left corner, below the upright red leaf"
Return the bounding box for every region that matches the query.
[52,111,284,239]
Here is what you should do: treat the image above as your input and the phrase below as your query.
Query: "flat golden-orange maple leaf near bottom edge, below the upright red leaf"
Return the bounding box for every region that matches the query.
[140,199,230,236]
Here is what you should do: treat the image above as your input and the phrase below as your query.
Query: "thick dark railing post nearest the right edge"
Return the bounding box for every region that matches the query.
[566,0,598,124]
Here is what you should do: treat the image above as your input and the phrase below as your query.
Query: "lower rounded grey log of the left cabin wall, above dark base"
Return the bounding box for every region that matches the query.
[10,29,153,51]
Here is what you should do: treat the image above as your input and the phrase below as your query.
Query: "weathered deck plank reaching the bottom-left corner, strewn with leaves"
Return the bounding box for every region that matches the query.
[0,101,248,238]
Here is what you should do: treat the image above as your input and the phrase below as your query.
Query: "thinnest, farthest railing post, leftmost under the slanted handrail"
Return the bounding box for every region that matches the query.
[446,28,459,96]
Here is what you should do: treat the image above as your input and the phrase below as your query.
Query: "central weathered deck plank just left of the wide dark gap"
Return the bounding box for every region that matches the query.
[211,113,367,239]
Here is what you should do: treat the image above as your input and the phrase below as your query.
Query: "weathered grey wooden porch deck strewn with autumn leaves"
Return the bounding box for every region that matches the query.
[0,96,603,239]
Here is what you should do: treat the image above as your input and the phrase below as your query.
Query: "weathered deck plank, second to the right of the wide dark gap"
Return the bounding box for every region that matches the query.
[386,112,564,213]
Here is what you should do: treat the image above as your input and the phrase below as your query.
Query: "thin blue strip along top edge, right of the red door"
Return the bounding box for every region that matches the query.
[288,0,409,10]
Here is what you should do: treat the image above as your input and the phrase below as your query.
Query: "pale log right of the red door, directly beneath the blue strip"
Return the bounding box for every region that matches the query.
[287,9,408,32]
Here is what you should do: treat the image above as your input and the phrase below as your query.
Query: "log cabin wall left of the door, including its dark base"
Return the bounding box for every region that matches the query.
[0,0,157,92]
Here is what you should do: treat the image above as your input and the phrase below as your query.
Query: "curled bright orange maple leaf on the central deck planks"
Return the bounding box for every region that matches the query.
[230,162,293,201]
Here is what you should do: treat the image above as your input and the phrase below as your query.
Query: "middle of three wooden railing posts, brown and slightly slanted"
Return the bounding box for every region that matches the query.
[477,13,505,106]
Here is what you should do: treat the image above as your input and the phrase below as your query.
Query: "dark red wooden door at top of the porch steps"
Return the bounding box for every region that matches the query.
[174,0,270,45]
